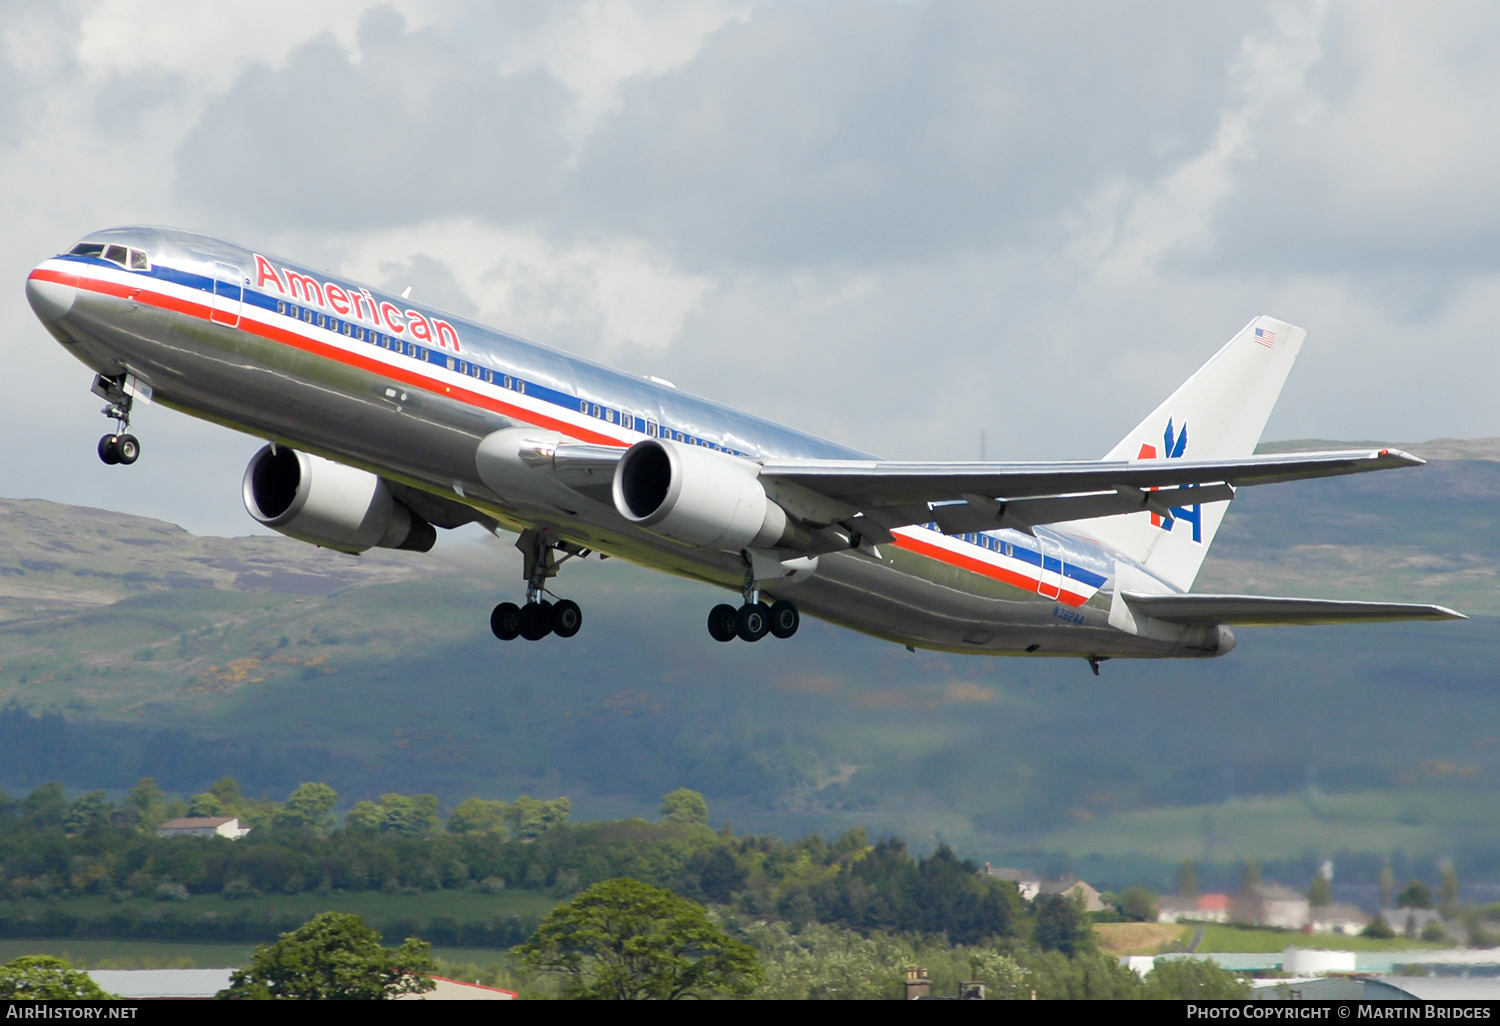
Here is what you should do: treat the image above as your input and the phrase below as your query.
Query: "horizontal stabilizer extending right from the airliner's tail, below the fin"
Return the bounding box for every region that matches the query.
[1122,593,1469,627]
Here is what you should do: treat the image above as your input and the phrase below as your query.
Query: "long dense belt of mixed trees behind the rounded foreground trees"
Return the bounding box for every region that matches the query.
[0,779,1068,951]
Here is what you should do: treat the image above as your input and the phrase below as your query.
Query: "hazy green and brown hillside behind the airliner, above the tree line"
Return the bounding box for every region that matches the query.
[0,443,1500,879]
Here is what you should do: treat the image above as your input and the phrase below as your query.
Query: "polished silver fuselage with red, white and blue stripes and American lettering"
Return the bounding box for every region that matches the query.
[27,228,1233,659]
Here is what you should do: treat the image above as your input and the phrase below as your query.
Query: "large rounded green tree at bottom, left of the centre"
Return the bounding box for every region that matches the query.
[515,878,764,1001]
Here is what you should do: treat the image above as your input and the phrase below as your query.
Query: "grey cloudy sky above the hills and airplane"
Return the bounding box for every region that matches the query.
[0,0,1500,534]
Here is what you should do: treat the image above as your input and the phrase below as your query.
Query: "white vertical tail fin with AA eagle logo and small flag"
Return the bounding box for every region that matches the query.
[1077,317,1307,591]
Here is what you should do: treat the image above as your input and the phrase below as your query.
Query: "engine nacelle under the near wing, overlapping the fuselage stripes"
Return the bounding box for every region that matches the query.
[614,438,800,552]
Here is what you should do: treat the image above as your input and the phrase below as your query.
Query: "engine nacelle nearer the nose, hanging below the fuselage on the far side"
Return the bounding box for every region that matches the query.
[242,446,438,552]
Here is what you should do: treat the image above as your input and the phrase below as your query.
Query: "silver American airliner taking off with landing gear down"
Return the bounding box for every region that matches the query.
[26,227,1463,675]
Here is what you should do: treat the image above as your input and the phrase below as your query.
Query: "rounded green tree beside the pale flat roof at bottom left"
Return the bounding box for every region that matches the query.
[219,912,438,1001]
